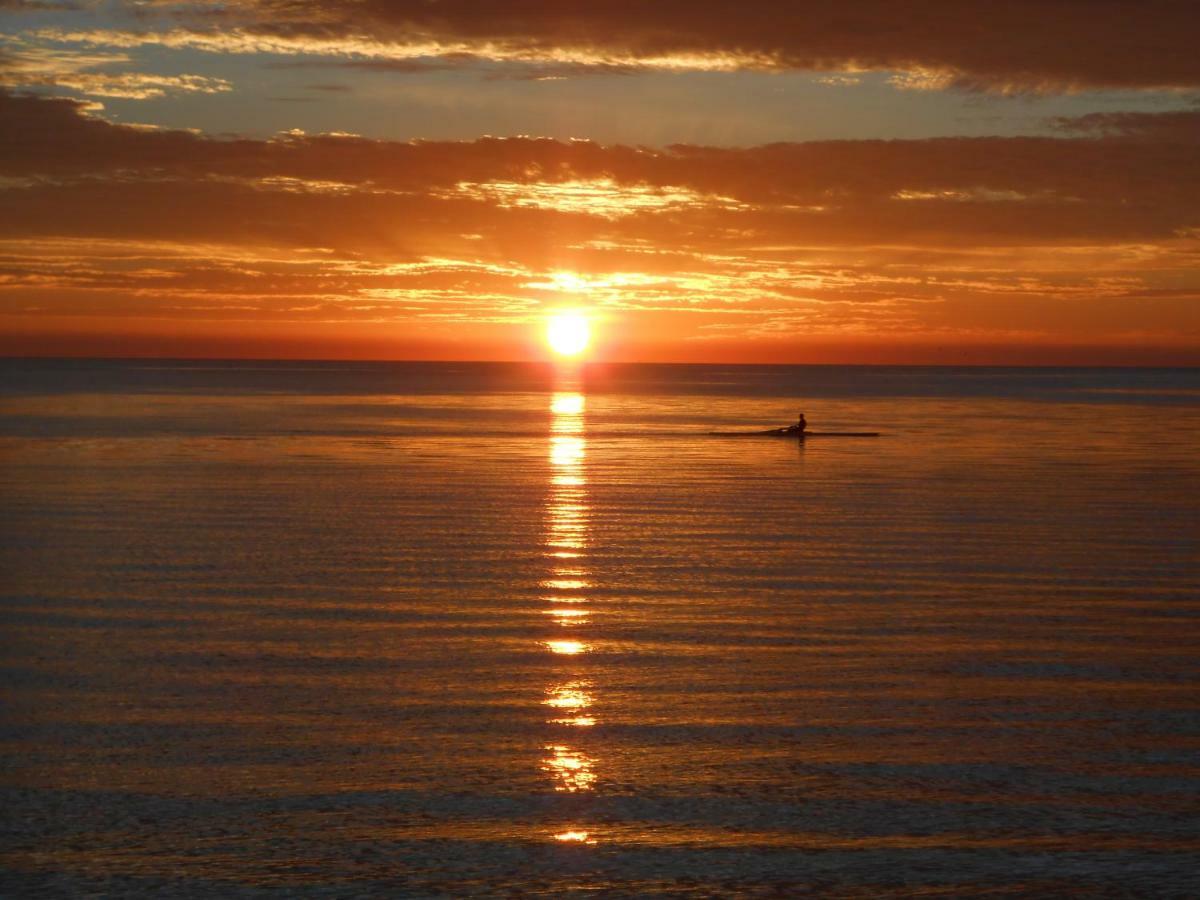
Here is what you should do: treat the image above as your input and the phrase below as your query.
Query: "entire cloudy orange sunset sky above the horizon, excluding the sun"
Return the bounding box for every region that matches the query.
[0,0,1200,365]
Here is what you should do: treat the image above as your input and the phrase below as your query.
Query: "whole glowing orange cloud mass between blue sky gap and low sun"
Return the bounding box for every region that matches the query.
[0,94,1200,347]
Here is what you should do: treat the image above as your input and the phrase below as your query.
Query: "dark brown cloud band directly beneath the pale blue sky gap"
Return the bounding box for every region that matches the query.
[0,95,1200,220]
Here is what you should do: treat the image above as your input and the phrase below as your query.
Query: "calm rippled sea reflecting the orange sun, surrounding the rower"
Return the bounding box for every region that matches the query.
[0,360,1200,896]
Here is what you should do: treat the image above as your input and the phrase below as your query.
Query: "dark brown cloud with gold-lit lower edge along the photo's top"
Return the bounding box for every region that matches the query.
[32,0,1200,92]
